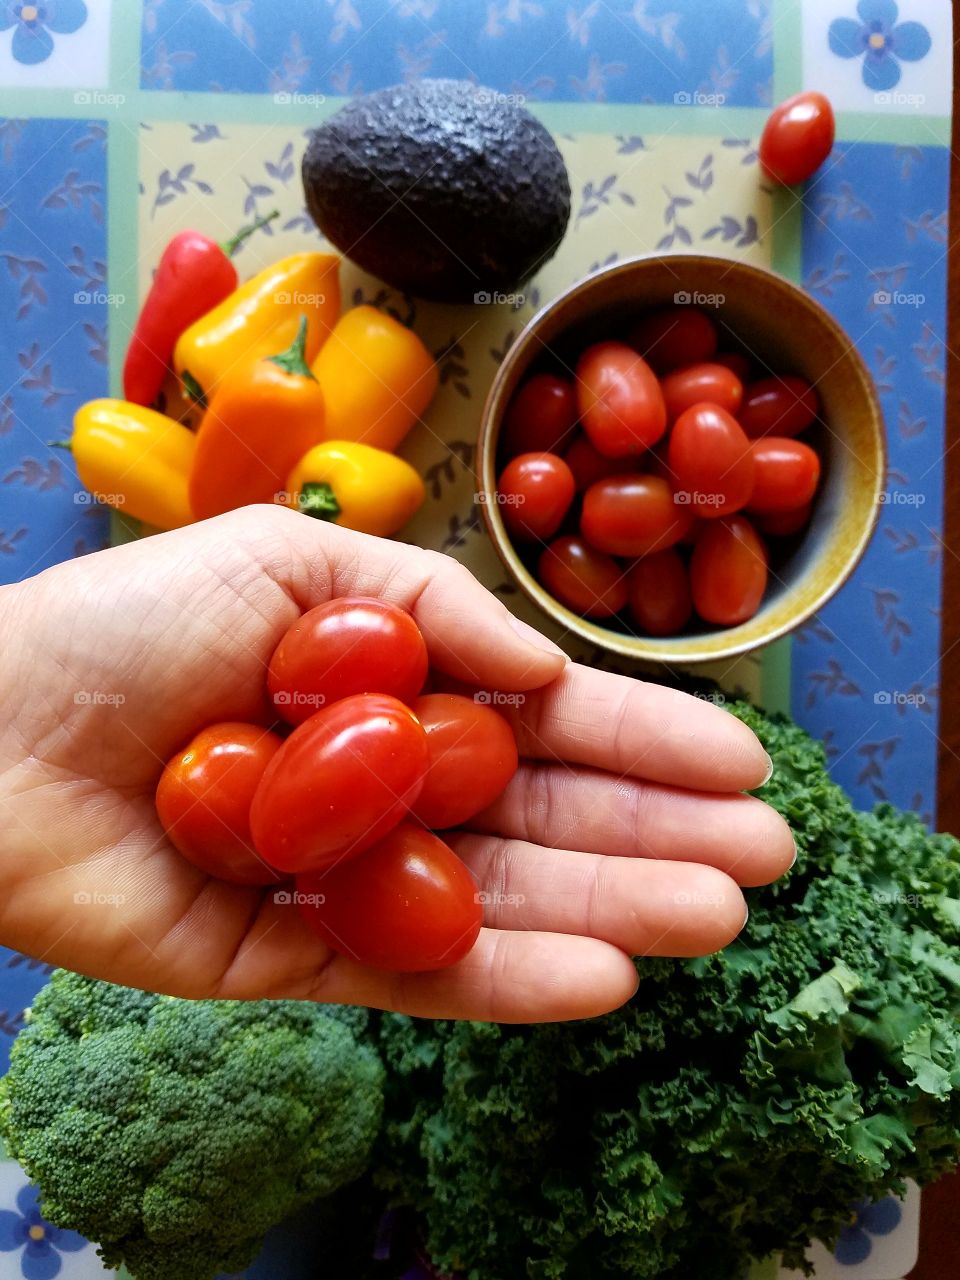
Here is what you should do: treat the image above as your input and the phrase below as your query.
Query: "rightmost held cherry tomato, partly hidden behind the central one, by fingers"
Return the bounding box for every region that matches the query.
[411,694,517,829]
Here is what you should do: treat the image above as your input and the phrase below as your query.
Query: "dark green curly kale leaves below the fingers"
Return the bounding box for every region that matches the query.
[378,704,960,1280]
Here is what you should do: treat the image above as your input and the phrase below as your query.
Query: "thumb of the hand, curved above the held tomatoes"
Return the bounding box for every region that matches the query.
[229,507,567,690]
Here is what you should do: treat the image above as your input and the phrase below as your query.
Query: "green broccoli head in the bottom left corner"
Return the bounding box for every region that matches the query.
[0,970,383,1280]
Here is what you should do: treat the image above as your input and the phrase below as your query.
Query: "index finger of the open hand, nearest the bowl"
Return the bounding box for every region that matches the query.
[504,663,771,791]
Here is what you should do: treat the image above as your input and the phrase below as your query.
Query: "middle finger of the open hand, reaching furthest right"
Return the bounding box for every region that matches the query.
[468,763,795,884]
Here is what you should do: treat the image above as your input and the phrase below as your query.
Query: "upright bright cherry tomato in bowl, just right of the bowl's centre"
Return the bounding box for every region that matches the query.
[667,404,754,520]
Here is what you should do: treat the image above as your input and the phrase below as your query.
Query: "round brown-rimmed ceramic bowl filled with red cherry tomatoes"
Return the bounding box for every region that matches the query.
[477,255,886,663]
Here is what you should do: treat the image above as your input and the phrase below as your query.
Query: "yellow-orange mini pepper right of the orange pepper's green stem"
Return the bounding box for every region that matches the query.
[311,306,438,452]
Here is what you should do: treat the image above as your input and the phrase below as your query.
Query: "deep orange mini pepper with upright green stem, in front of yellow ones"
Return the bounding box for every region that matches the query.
[189,316,324,520]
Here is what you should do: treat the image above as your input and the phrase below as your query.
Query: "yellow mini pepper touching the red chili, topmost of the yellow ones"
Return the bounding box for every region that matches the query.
[173,253,340,399]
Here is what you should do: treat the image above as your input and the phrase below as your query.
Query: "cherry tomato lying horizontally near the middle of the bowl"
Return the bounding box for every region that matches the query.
[580,474,692,557]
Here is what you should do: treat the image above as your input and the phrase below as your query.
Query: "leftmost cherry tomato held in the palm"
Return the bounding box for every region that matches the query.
[156,722,283,884]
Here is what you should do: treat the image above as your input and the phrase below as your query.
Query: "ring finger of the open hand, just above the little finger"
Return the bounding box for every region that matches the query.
[451,832,746,956]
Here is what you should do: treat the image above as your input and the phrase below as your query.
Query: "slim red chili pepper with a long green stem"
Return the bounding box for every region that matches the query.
[123,210,279,404]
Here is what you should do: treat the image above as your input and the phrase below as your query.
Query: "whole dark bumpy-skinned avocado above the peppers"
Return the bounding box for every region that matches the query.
[302,79,570,302]
